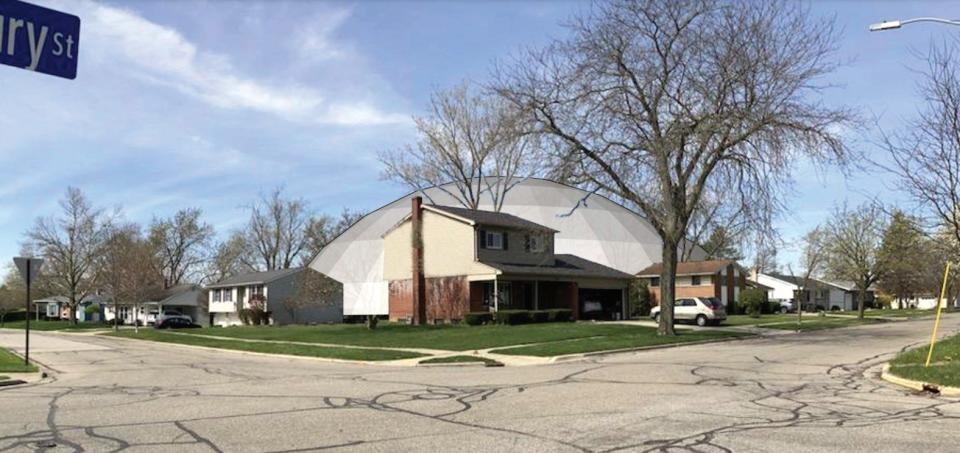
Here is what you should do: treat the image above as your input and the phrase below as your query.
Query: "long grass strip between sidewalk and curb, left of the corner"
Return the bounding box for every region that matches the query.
[106,329,426,361]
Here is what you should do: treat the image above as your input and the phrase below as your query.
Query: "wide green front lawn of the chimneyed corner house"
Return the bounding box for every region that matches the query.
[178,322,696,351]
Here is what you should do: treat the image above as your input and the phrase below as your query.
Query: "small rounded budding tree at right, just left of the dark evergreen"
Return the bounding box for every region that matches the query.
[825,205,888,318]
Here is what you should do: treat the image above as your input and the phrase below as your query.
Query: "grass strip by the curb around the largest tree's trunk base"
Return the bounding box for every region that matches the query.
[491,327,748,357]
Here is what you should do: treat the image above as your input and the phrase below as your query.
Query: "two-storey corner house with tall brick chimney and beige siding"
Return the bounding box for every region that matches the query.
[383,197,632,322]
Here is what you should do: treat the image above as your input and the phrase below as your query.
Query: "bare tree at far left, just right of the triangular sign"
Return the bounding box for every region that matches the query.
[27,187,110,324]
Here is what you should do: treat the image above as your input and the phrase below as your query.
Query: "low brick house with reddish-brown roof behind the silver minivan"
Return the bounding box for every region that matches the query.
[637,260,745,312]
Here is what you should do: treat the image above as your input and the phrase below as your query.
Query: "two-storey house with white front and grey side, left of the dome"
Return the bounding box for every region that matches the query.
[207,268,343,326]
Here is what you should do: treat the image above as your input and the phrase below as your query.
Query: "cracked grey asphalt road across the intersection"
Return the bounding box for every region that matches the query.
[0,315,960,452]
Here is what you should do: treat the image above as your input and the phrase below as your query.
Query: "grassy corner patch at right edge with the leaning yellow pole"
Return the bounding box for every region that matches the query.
[890,335,960,387]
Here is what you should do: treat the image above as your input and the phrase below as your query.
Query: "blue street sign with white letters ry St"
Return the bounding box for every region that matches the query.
[0,0,80,79]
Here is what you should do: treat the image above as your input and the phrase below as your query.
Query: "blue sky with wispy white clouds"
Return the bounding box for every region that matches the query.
[0,0,960,270]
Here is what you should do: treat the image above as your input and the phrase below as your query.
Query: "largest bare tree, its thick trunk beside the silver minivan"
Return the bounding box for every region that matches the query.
[497,0,851,335]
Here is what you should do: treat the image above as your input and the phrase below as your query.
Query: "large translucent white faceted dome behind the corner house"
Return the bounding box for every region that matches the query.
[310,178,702,315]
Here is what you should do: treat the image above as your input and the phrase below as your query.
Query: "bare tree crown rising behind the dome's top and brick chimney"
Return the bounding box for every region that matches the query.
[380,84,536,211]
